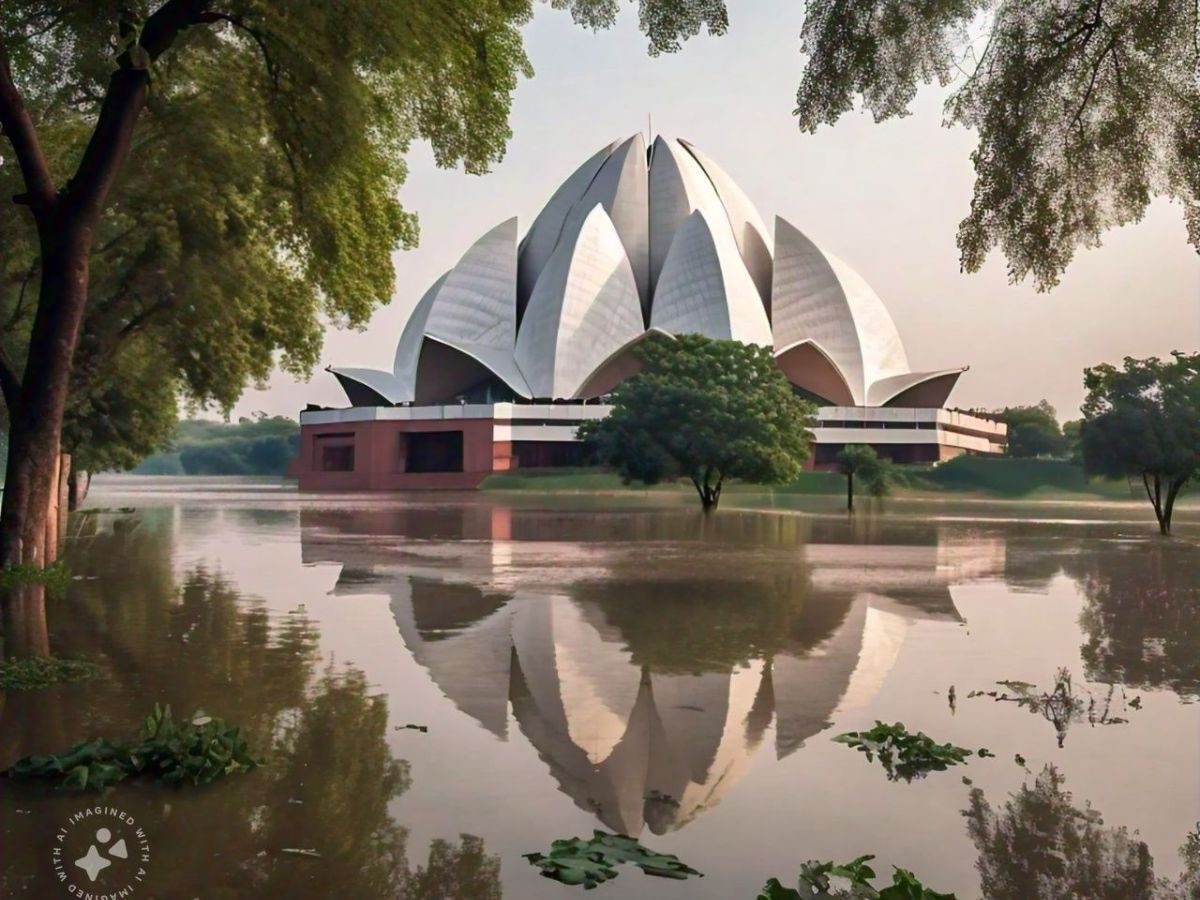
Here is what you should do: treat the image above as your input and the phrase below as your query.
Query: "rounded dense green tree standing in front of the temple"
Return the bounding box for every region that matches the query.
[580,335,815,511]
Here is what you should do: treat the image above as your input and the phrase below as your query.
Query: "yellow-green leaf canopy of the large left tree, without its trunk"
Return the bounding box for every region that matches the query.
[0,0,532,469]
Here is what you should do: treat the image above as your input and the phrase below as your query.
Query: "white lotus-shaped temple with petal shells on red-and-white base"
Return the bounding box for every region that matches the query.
[293,133,1006,490]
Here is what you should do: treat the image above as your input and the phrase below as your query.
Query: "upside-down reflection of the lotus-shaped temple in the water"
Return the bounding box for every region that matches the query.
[302,504,1004,834]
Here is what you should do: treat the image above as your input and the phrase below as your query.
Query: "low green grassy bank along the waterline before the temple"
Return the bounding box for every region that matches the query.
[482,456,1138,500]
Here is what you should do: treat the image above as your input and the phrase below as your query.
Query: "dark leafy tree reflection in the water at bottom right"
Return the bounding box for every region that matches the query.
[964,766,1156,900]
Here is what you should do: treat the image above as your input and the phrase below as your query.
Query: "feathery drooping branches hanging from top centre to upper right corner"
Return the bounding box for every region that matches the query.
[564,0,1200,290]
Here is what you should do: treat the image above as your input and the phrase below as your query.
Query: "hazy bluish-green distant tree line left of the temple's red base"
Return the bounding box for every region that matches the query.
[133,415,300,475]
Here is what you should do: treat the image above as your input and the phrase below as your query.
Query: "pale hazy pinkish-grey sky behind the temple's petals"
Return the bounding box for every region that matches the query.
[234,0,1200,419]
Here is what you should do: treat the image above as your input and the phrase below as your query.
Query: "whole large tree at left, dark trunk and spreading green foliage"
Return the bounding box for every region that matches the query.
[0,0,585,564]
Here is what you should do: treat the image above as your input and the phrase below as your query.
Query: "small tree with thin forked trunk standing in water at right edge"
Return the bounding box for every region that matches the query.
[1080,352,1200,534]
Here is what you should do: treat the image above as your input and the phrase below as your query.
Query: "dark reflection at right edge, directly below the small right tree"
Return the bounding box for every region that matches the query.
[1066,541,1200,695]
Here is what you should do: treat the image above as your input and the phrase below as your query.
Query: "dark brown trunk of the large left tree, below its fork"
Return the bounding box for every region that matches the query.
[0,236,91,566]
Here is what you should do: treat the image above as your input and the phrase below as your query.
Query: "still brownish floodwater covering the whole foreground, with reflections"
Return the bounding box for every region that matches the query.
[0,478,1200,900]
